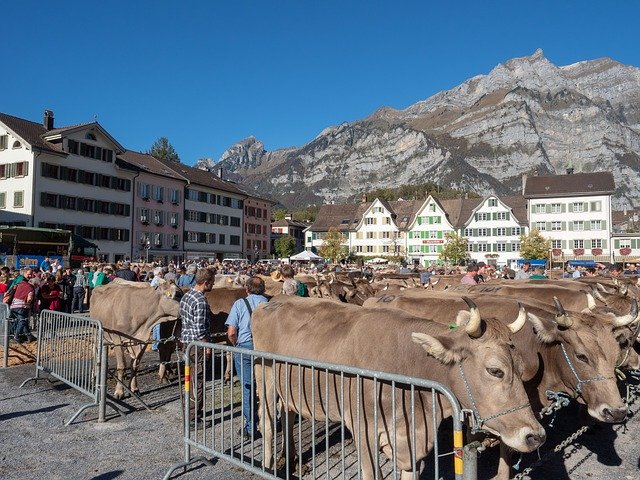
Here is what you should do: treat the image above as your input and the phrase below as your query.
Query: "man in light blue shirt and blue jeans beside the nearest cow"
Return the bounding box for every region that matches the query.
[225,277,267,438]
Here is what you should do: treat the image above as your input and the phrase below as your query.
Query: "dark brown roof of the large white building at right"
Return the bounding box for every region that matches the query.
[523,172,615,198]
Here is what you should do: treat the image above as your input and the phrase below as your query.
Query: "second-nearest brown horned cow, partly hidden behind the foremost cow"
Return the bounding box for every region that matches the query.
[365,291,637,479]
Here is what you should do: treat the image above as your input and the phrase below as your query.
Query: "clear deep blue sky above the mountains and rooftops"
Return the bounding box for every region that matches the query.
[0,0,640,164]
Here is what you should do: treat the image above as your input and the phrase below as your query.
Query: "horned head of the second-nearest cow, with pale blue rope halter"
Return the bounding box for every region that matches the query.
[531,298,638,423]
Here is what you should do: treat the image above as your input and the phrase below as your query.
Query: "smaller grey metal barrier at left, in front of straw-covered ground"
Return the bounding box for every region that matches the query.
[20,310,120,425]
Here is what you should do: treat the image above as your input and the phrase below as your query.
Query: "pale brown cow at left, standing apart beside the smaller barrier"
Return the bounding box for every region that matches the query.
[90,281,182,399]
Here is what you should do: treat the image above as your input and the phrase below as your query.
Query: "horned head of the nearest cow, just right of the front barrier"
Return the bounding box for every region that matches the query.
[412,298,546,452]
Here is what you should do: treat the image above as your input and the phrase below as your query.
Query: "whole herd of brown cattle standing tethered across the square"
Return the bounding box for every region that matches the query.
[91,272,640,479]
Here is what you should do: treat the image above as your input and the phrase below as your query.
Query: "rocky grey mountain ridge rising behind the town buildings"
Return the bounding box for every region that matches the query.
[197,49,640,208]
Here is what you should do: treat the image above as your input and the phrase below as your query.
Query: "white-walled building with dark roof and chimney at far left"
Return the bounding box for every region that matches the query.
[0,111,135,261]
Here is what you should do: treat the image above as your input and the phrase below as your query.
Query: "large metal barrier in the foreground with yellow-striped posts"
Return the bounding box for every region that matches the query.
[164,342,477,480]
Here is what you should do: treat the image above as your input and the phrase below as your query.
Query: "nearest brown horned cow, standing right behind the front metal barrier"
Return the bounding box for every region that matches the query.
[253,296,545,480]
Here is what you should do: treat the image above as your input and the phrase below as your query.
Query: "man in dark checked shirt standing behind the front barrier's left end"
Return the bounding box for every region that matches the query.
[180,268,215,419]
